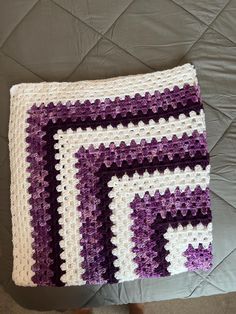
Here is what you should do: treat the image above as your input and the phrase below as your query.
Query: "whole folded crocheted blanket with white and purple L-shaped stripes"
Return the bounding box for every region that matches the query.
[9,64,212,286]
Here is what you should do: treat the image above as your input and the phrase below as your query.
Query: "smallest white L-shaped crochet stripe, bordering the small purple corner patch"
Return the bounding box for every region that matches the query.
[164,223,212,275]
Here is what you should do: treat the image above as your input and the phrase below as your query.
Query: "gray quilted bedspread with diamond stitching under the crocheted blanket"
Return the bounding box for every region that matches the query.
[0,0,236,310]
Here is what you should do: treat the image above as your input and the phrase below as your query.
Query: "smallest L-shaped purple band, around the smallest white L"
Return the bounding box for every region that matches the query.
[130,186,211,278]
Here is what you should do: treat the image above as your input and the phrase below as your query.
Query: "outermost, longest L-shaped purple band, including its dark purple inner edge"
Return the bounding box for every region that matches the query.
[26,85,202,286]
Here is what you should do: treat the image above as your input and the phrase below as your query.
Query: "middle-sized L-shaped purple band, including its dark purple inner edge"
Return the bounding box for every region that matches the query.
[76,132,209,284]
